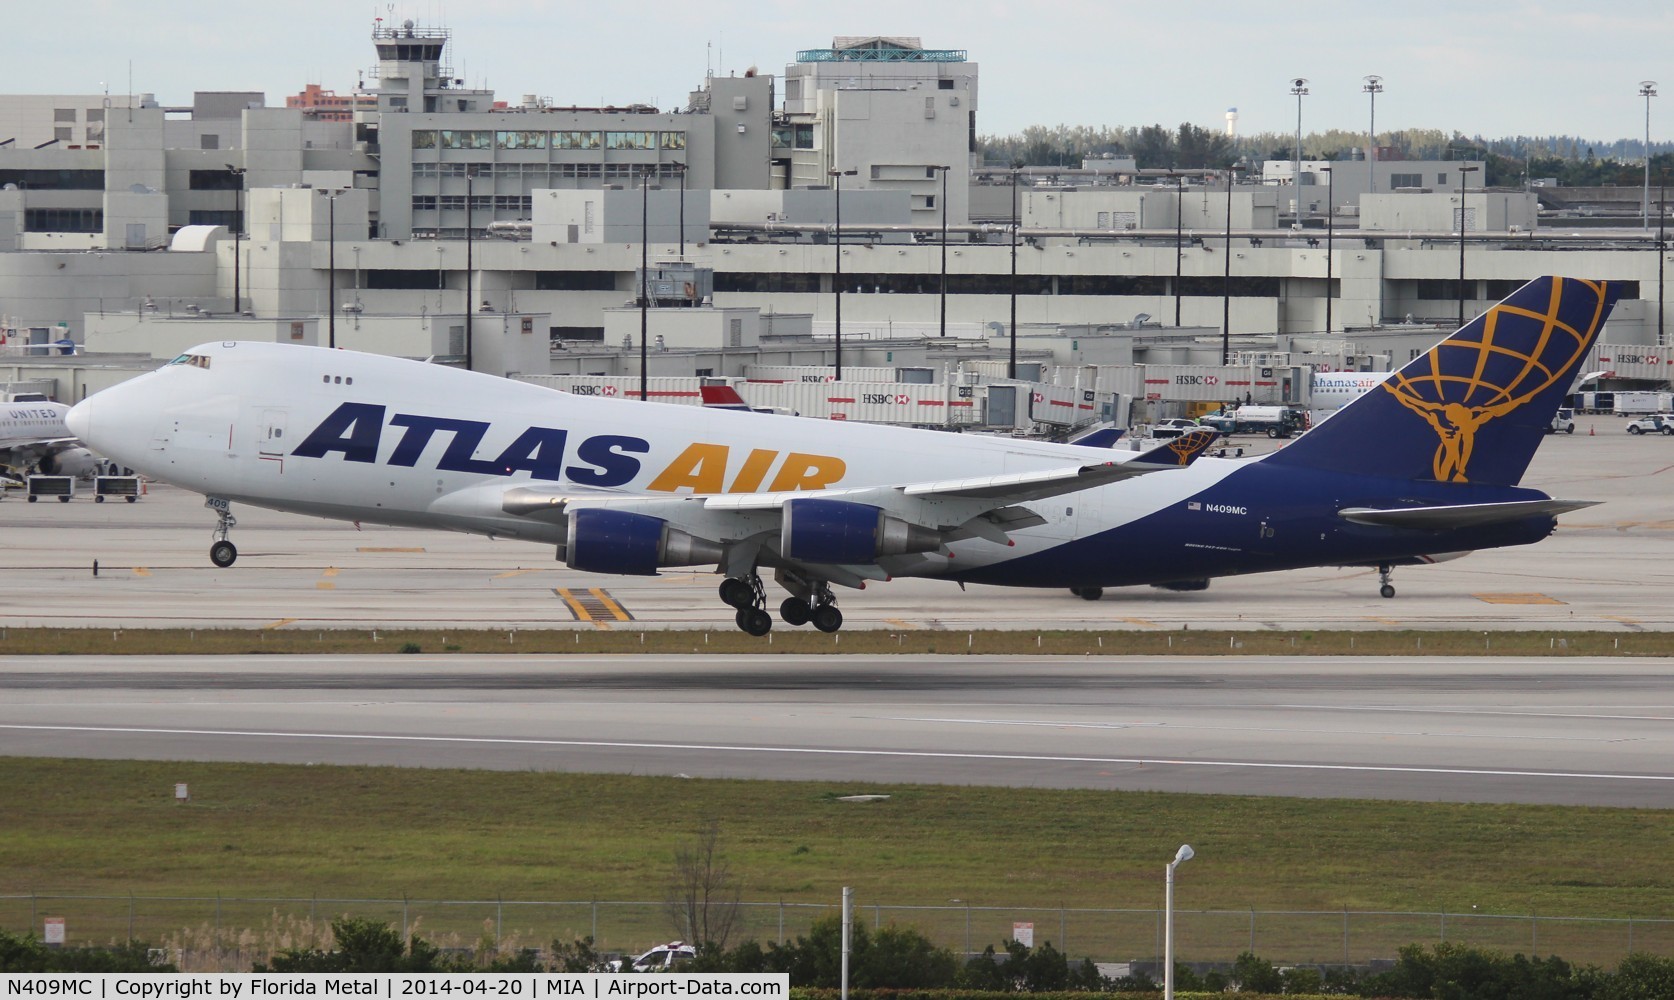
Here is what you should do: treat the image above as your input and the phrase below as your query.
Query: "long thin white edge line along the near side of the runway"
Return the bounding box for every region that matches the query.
[0,724,1674,782]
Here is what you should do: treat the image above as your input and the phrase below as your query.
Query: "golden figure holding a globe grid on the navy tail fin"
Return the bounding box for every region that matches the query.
[1383,280,1604,482]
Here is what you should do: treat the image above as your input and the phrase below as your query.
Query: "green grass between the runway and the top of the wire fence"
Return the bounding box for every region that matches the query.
[0,759,1674,918]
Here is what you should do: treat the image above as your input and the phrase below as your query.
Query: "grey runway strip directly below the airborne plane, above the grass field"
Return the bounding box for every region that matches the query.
[0,655,1674,807]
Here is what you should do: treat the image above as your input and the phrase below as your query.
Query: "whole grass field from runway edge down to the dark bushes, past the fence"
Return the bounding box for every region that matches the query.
[0,757,1674,970]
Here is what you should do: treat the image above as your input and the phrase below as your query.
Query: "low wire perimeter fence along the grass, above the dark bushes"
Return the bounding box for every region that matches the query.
[0,894,1674,972]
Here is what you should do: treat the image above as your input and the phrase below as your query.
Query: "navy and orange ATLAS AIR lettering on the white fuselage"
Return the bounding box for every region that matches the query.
[291,402,847,492]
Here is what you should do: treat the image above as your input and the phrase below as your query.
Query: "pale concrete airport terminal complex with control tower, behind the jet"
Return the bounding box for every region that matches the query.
[0,22,1667,427]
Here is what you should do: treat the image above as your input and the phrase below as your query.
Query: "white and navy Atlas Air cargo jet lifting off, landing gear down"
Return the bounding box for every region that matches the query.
[69,278,1615,635]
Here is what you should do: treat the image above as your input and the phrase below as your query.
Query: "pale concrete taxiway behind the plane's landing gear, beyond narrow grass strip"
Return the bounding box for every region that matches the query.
[0,425,1674,631]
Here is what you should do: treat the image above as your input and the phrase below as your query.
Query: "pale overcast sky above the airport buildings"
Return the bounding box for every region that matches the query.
[22,0,1674,142]
